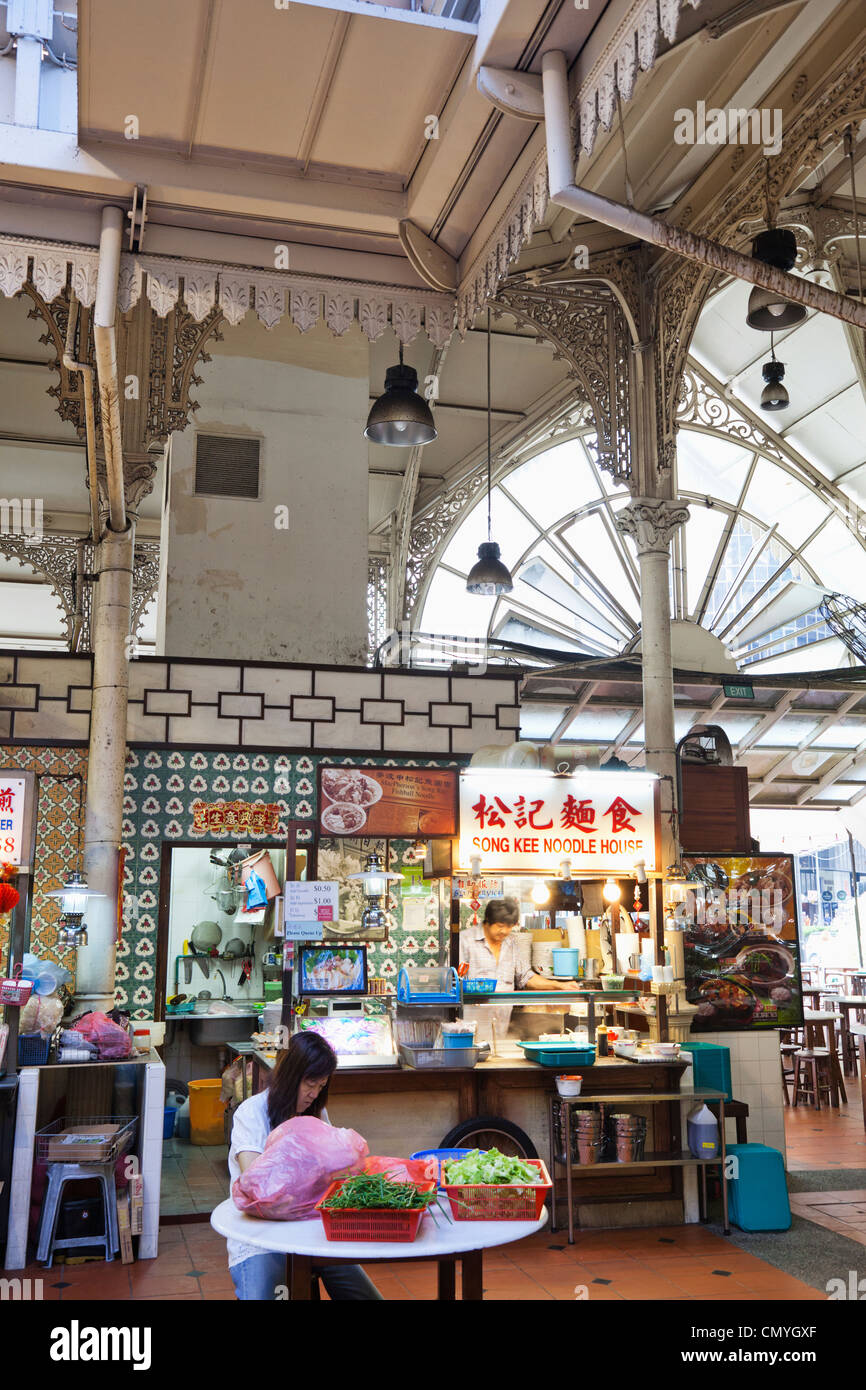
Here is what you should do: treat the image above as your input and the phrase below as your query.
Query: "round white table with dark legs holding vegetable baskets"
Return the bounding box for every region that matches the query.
[210,1197,548,1301]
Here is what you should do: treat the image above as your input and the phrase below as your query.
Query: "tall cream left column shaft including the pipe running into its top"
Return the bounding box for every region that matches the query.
[75,207,135,1011]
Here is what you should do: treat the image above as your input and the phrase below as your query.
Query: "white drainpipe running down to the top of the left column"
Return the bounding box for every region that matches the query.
[93,207,126,531]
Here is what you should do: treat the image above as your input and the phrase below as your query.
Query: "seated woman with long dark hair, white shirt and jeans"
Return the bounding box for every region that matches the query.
[227,1033,382,1300]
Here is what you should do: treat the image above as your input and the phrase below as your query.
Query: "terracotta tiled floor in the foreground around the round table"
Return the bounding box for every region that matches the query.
[13,1225,824,1302]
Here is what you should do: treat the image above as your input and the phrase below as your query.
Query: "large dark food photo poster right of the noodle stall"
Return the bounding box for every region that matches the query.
[677,855,803,1033]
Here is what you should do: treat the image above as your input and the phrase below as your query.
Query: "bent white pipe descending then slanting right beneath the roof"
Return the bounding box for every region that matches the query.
[542,51,866,328]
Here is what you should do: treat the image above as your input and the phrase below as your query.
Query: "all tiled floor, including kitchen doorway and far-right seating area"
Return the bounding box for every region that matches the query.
[26,1056,866,1302]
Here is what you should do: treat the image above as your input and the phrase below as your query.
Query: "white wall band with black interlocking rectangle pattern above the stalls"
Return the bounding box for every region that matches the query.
[0,652,520,758]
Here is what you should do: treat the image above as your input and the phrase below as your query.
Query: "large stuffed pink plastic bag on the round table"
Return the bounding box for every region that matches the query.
[232,1115,370,1220]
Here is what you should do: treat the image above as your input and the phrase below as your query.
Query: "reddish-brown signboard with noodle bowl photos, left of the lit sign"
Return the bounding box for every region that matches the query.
[318,766,457,840]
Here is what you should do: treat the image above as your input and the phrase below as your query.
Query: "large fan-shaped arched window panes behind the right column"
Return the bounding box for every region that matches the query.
[414,347,866,671]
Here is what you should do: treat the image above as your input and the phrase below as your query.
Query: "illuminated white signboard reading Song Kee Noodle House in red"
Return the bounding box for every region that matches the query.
[459,769,659,878]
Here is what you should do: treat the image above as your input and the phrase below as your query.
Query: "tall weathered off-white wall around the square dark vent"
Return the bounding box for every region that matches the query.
[157,314,368,664]
